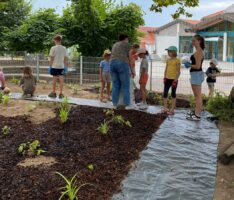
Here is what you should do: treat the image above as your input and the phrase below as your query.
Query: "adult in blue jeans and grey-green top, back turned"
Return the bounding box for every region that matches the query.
[110,35,131,107]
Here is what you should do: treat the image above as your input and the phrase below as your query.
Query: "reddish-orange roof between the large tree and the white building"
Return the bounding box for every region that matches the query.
[138,26,157,46]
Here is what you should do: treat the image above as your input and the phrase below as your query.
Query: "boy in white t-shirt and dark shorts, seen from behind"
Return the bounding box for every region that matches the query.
[49,35,68,99]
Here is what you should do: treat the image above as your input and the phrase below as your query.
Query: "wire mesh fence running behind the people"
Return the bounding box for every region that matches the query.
[0,52,234,95]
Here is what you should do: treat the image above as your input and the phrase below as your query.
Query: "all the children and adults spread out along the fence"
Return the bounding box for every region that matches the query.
[0,34,220,121]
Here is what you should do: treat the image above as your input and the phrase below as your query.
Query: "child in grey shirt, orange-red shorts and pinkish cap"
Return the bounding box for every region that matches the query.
[137,48,149,110]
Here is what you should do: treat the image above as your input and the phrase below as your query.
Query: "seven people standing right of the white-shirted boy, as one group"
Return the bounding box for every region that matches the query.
[100,35,220,121]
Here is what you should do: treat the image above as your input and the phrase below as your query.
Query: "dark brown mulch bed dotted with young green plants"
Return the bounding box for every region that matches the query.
[0,106,165,200]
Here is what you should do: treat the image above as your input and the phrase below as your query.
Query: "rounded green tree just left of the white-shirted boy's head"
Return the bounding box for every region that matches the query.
[5,9,61,53]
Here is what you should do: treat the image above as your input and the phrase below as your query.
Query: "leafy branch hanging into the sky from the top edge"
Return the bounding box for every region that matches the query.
[151,0,199,19]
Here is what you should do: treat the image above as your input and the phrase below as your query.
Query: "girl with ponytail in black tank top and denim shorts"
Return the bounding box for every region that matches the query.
[185,35,205,121]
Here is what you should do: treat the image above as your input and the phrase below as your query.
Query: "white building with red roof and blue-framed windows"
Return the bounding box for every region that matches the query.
[155,4,234,62]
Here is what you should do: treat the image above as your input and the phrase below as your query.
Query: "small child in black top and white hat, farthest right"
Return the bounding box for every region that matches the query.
[206,58,220,97]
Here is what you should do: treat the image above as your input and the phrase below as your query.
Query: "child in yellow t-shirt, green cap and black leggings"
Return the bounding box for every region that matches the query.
[163,46,181,115]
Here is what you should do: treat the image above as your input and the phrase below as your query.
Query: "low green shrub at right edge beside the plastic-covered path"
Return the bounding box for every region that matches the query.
[206,93,234,122]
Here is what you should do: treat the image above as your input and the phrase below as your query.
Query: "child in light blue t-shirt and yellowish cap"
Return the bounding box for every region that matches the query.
[99,49,111,101]
